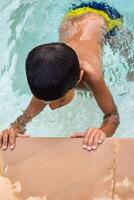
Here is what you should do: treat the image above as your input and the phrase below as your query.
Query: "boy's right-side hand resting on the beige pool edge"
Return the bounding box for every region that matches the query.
[71,128,106,151]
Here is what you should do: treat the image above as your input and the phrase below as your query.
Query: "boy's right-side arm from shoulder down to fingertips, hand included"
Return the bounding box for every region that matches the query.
[71,62,120,150]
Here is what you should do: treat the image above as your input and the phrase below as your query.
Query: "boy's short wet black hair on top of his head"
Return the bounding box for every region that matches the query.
[26,43,80,101]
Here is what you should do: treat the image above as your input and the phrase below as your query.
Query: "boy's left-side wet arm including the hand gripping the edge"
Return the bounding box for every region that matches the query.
[0,96,47,150]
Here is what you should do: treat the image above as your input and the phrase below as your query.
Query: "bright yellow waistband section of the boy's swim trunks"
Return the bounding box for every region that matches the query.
[65,7,123,32]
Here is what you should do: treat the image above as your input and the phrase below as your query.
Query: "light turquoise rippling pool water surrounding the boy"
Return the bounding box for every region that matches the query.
[0,0,134,137]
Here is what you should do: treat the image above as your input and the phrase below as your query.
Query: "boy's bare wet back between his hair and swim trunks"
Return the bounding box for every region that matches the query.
[60,13,106,69]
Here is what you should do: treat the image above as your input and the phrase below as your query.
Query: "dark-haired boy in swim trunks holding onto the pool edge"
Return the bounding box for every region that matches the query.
[0,2,122,150]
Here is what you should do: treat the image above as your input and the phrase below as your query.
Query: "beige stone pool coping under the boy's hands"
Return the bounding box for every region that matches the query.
[0,138,134,200]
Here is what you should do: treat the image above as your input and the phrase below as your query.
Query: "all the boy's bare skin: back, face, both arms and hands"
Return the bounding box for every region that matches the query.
[0,14,119,150]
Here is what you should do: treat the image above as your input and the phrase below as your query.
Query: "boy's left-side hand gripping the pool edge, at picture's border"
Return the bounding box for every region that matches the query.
[0,127,29,150]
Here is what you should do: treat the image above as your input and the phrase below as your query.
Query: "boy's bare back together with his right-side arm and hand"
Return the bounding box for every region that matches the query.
[60,13,119,150]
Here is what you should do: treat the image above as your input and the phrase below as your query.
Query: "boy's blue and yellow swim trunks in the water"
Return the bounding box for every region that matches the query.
[65,1,123,37]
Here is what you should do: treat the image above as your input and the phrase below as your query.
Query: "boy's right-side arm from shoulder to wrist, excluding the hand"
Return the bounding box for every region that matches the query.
[85,70,119,137]
